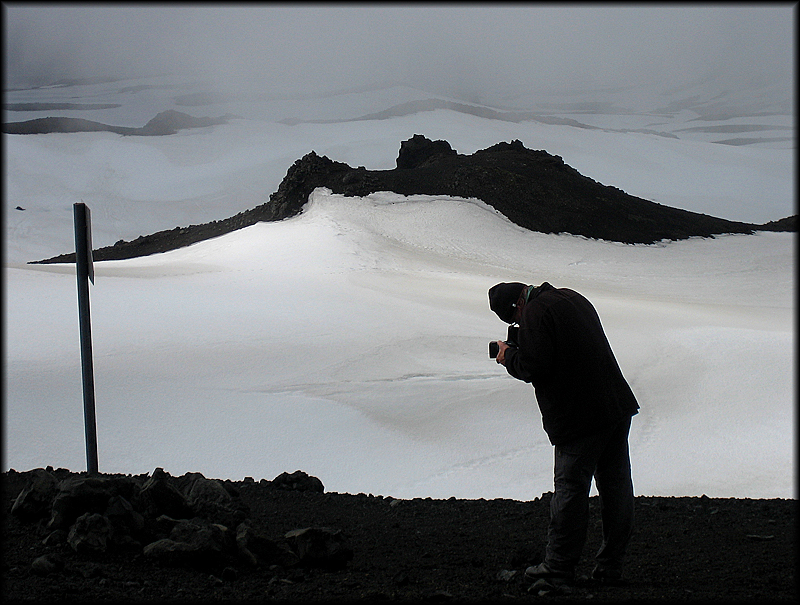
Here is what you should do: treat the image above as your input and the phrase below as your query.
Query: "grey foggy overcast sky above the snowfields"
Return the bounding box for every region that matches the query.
[3,3,796,98]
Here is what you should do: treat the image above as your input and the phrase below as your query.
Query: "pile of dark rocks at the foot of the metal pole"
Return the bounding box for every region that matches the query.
[11,468,353,575]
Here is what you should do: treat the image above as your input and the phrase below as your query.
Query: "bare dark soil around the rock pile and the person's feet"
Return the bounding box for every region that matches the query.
[2,469,797,603]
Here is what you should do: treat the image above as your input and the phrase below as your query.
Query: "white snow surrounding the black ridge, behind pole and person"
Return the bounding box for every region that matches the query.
[3,75,796,500]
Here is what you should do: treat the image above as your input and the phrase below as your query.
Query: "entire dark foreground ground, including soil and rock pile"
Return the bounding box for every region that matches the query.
[2,467,797,603]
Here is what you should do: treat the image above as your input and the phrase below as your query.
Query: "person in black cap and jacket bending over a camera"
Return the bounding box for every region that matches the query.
[489,282,639,582]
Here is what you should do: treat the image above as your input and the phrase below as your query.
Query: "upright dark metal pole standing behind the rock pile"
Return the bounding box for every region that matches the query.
[73,203,98,474]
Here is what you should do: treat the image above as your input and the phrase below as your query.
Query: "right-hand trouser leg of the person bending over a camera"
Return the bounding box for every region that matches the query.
[595,418,634,575]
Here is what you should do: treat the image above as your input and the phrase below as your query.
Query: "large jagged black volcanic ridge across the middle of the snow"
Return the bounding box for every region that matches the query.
[29,136,797,263]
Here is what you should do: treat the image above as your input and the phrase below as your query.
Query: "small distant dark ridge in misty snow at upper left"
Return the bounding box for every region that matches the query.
[3,105,235,136]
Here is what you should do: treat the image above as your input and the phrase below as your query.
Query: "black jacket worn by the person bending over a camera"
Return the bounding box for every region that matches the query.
[505,282,639,445]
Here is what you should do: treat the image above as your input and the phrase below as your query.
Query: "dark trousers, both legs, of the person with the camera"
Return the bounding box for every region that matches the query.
[545,418,633,572]
